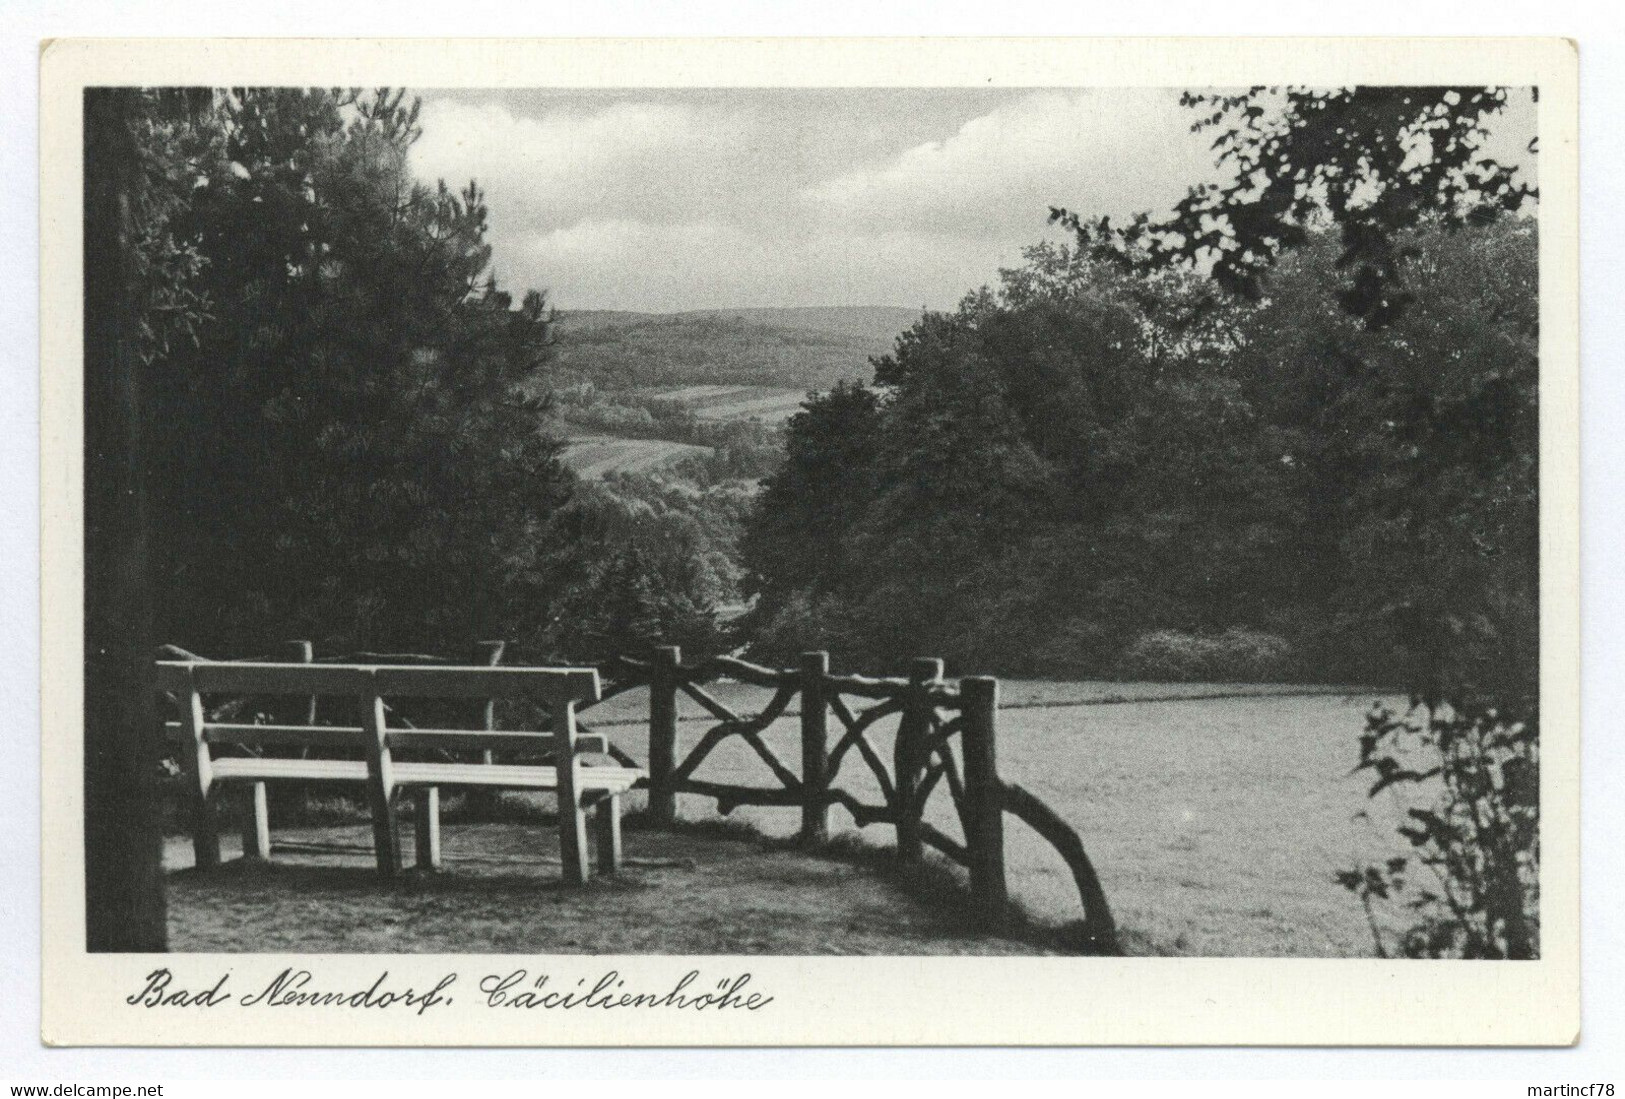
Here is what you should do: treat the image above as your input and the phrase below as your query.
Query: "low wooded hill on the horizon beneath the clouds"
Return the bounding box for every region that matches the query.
[548,306,918,392]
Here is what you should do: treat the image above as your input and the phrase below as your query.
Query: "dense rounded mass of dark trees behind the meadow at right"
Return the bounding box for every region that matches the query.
[744,218,1539,686]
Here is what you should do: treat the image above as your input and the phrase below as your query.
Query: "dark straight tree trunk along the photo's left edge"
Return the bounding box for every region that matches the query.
[85,88,167,951]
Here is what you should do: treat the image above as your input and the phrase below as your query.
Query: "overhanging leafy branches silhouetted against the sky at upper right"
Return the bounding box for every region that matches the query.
[1051,86,1536,328]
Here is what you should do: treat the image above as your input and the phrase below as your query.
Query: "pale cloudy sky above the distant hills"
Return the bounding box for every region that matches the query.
[413,89,1526,312]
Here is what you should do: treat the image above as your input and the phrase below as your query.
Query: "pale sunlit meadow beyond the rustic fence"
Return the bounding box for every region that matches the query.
[587,681,1402,958]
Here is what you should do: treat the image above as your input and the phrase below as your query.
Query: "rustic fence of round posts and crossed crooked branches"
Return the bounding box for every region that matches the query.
[166,642,1118,953]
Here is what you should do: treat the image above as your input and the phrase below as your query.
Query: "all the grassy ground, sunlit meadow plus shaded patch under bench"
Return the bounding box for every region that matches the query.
[166,681,1401,958]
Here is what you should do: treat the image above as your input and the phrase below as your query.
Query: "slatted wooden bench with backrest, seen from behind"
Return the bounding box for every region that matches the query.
[158,660,645,883]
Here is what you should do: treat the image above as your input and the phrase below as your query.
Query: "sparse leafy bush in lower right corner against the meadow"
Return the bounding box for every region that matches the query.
[1337,699,1541,959]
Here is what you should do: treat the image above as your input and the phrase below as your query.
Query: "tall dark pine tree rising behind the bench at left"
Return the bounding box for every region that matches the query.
[141,88,572,652]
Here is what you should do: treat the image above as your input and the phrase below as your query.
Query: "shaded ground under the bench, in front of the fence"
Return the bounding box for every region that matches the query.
[166,823,1045,954]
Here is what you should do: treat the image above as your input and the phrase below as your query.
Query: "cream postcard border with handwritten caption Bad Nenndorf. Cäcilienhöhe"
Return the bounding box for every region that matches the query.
[41,39,1580,1045]
